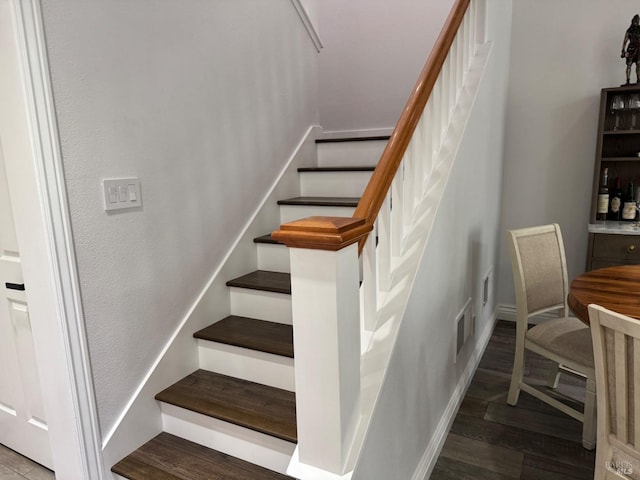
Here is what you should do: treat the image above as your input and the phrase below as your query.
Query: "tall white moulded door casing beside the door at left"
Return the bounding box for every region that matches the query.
[12,0,105,480]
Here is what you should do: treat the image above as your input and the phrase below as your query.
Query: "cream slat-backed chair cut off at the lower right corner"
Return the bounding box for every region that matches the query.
[589,305,640,480]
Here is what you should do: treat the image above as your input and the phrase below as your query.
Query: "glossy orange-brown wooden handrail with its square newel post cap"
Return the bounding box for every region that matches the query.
[272,0,471,251]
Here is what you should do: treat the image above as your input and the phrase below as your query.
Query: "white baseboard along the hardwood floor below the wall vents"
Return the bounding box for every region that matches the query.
[411,312,496,480]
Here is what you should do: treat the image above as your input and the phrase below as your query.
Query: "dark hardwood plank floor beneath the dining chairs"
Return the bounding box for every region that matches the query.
[430,321,595,480]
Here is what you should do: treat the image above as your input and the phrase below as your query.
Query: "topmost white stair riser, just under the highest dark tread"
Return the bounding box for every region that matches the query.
[318,140,387,167]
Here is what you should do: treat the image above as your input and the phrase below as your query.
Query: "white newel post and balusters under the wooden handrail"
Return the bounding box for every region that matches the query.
[291,0,485,480]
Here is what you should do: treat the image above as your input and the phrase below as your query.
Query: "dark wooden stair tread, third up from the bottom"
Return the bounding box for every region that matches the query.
[193,315,293,358]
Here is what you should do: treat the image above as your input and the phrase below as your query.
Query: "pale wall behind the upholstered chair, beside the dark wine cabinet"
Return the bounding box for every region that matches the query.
[498,0,639,306]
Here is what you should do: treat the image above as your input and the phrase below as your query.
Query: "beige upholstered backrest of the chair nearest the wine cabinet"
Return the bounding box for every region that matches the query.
[507,223,569,321]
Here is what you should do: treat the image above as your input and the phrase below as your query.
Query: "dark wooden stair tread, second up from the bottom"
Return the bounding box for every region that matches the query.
[156,370,297,443]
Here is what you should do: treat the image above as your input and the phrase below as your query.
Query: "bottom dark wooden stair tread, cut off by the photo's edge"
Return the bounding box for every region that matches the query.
[111,432,292,480]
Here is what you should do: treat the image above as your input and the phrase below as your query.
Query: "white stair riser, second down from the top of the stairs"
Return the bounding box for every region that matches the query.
[299,172,372,197]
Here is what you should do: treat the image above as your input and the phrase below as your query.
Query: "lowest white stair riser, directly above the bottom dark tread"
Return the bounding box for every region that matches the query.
[160,402,295,474]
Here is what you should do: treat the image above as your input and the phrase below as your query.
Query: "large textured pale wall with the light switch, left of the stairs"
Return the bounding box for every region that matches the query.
[38,0,318,435]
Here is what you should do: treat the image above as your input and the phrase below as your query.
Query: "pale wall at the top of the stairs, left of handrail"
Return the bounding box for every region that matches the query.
[316,0,453,132]
